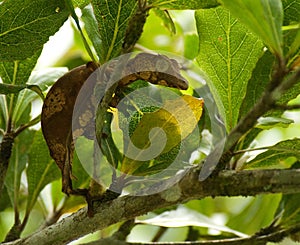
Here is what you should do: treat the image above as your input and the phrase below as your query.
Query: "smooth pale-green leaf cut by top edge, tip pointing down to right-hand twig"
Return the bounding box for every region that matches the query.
[221,0,283,57]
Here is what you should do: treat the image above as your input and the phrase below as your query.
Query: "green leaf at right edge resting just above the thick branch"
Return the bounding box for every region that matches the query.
[244,139,300,168]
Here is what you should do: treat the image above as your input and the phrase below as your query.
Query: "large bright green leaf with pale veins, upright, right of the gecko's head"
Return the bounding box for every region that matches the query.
[195,7,263,131]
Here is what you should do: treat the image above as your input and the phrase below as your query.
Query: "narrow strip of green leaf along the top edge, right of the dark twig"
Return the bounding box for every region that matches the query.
[150,0,220,10]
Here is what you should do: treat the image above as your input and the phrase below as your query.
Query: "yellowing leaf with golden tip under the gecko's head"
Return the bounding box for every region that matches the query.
[121,95,204,174]
